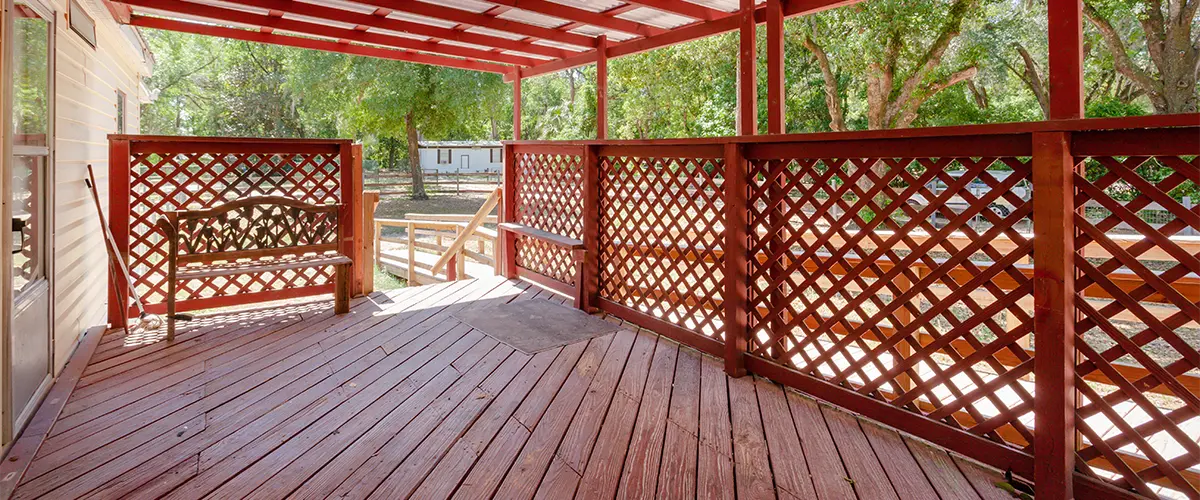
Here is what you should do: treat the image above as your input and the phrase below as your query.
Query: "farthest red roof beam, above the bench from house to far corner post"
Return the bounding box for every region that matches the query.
[130,14,510,73]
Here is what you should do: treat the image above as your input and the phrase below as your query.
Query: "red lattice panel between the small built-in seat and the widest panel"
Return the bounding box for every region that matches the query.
[600,157,725,338]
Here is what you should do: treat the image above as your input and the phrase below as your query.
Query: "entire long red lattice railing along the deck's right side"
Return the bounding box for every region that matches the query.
[499,115,1200,498]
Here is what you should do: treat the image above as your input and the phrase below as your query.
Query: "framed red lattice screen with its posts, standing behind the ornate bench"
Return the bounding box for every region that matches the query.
[109,135,361,311]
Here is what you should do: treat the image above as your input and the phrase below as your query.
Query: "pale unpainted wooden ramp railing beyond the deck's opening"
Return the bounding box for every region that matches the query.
[373,188,500,285]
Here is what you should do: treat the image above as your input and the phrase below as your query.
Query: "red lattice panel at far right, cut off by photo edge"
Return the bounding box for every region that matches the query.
[1075,156,1200,498]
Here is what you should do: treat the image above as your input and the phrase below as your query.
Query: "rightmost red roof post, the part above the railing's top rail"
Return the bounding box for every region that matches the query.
[1048,0,1084,120]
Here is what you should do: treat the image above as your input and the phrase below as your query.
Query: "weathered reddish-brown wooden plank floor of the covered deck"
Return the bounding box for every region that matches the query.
[14,279,1009,500]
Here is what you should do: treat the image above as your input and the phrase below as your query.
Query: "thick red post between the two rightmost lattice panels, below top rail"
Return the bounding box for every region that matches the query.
[1033,132,1075,500]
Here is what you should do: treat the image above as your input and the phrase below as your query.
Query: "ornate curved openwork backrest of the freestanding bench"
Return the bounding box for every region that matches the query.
[158,197,342,265]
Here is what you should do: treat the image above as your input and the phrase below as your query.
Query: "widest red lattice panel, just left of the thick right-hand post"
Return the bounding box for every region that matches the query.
[748,157,1033,445]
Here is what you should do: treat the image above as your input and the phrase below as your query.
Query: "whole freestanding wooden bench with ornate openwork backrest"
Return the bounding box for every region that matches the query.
[157,197,353,341]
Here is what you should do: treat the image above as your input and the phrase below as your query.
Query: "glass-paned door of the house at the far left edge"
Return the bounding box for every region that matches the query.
[5,1,54,429]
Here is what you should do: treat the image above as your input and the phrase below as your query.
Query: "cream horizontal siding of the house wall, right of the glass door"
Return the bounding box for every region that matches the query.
[53,0,150,374]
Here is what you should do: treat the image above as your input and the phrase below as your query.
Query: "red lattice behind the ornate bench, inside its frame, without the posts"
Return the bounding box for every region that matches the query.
[128,152,341,303]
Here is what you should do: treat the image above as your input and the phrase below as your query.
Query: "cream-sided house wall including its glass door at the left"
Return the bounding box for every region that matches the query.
[0,0,151,446]
